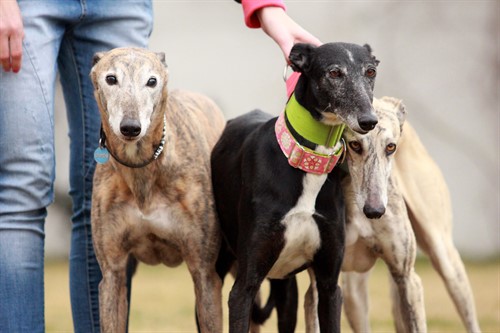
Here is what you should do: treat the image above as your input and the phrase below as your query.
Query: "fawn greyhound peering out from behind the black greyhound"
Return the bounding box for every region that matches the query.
[342,97,480,332]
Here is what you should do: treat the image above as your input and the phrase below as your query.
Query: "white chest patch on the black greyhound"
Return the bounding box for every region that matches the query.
[268,174,327,279]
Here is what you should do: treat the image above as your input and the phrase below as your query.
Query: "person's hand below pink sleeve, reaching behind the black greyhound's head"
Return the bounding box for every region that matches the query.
[256,7,322,63]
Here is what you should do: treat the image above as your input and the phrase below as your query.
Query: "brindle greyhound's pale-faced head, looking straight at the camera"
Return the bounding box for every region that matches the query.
[90,48,168,142]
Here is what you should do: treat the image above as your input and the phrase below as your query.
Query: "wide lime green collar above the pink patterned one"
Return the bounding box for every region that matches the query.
[285,94,345,147]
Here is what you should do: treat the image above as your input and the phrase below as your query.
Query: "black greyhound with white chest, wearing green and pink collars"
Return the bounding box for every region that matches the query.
[211,43,378,333]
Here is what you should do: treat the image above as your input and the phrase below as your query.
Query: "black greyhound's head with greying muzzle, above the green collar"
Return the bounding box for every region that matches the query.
[289,43,379,134]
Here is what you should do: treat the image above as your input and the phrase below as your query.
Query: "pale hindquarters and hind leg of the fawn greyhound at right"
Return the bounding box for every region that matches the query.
[394,123,481,333]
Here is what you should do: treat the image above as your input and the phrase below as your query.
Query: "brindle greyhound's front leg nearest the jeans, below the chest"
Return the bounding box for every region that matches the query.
[99,267,128,333]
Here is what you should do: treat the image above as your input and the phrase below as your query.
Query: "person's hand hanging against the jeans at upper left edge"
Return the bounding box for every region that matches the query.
[0,0,24,73]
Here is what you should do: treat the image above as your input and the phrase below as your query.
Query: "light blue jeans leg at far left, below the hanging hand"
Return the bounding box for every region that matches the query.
[0,4,61,333]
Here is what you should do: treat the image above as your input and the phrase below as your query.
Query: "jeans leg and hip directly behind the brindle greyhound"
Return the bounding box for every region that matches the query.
[58,0,152,333]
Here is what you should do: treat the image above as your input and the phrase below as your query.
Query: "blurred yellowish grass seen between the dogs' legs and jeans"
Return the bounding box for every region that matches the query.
[45,259,500,333]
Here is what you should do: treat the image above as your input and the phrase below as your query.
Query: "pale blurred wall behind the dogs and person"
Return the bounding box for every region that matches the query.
[46,0,500,259]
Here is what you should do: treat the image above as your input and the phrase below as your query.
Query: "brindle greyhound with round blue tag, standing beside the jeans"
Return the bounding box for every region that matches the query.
[91,48,224,333]
